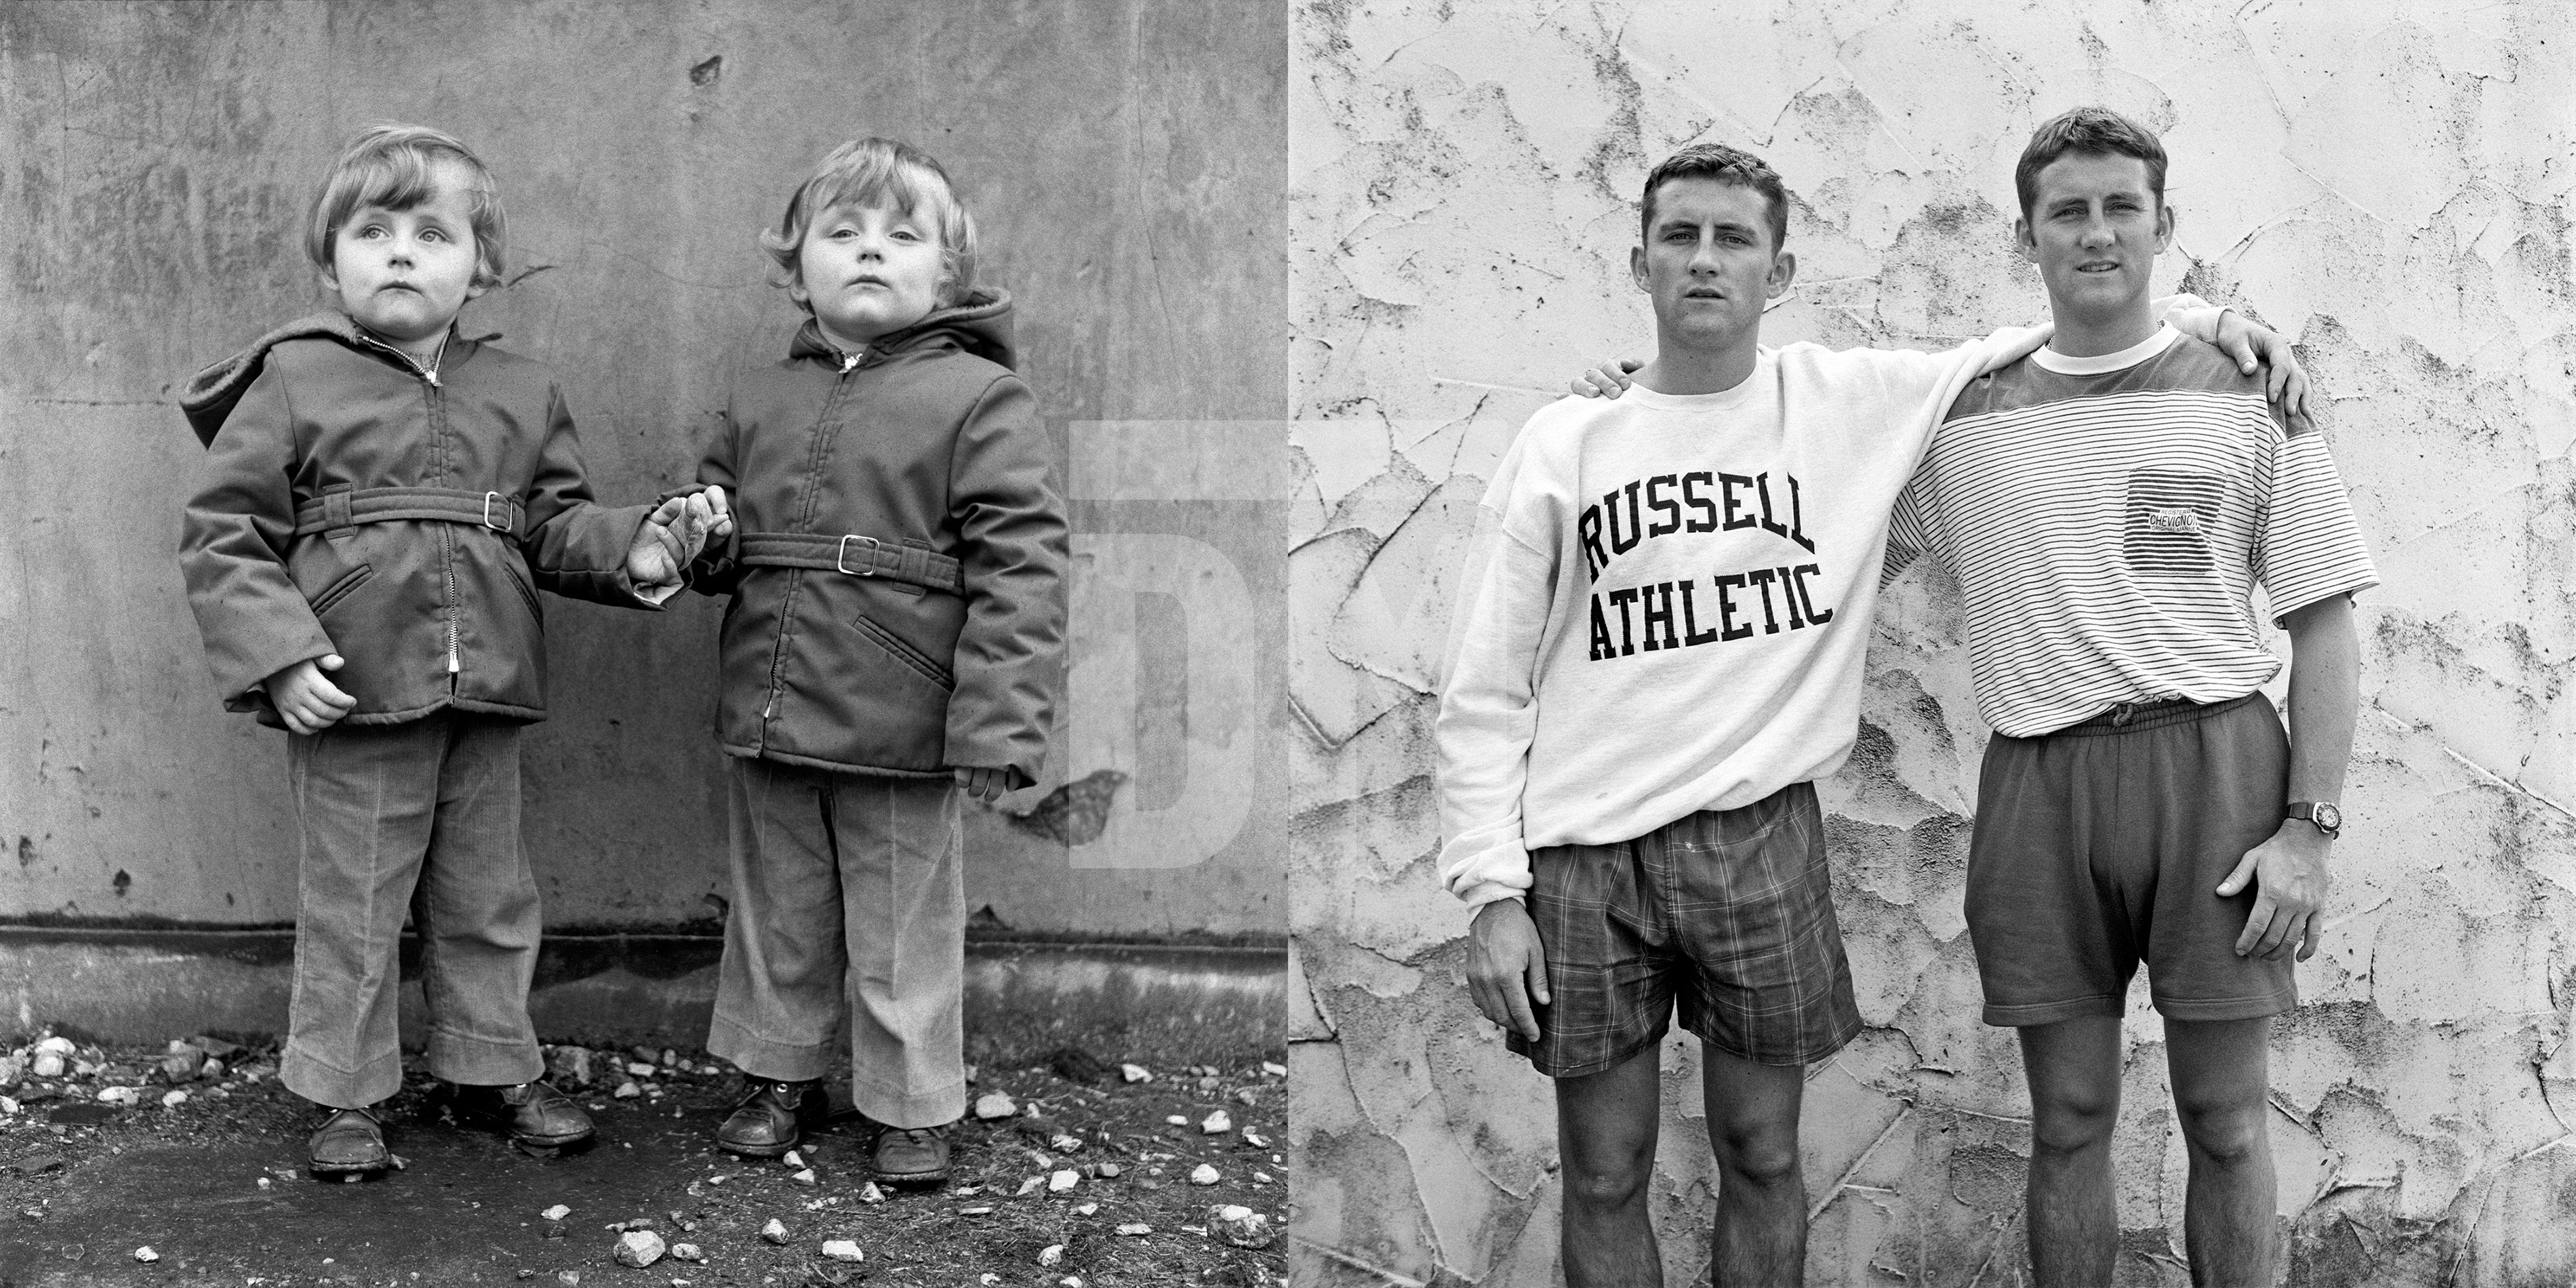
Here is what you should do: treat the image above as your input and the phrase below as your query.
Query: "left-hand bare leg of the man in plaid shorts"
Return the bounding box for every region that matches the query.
[1556,1046,1664,1288]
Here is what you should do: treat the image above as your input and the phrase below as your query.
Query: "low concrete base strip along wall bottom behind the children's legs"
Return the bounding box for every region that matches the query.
[0,927,1288,1066]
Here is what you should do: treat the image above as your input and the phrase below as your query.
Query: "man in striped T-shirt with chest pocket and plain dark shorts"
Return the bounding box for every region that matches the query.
[1888,108,2377,1285]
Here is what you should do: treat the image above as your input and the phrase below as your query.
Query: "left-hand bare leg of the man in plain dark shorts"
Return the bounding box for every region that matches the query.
[2022,1015,2120,1288]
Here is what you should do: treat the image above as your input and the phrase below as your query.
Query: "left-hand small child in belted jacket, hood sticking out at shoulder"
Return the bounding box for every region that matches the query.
[180,126,721,1172]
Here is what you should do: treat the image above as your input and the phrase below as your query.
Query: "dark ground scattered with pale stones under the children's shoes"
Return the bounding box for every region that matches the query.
[0,1038,1288,1288]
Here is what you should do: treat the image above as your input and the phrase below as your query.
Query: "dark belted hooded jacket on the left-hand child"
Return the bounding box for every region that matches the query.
[180,315,651,724]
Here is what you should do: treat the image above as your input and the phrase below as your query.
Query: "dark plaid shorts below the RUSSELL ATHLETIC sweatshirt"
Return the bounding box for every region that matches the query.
[1507,783,1860,1076]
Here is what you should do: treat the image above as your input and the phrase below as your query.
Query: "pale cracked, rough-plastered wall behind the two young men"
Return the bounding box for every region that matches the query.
[1288,0,2576,1288]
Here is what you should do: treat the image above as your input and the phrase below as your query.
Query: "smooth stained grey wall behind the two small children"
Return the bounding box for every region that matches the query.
[0,0,1285,938]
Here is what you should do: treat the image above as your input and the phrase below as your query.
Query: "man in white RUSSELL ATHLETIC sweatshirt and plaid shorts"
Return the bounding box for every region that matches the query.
[1437,144,2303,1288]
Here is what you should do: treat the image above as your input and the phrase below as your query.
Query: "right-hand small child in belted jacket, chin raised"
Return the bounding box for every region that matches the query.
[693,139,1066,1185]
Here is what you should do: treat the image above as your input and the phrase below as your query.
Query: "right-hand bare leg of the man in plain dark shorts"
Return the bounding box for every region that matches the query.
[2164,1015,2277,1288]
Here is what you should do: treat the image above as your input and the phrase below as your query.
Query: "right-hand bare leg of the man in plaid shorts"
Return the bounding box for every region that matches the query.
[1700,1043,1806,1288]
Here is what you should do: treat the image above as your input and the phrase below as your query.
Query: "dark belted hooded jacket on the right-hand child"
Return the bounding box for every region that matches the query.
[693,289,1066,783]
